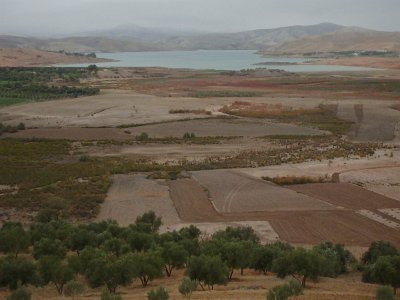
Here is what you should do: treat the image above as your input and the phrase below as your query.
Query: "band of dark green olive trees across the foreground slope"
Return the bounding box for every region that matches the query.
[0,211,400,300]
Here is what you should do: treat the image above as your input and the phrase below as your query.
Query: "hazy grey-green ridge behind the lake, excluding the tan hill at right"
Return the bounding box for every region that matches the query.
[0,23,343,52]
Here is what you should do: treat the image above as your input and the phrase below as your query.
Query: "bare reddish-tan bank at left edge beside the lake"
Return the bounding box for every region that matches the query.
[0,48,108,67]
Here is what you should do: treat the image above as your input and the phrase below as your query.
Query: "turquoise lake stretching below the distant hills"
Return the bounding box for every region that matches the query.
[58,50,378,72]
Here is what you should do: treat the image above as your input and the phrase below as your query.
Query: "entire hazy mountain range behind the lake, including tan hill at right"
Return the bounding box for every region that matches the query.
[0,23,400,53]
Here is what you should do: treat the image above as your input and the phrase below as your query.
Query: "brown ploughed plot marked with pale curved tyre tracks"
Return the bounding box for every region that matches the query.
[192,170,334,213]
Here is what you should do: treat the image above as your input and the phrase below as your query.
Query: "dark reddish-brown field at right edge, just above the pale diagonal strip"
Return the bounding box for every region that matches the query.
[290,183,400,210]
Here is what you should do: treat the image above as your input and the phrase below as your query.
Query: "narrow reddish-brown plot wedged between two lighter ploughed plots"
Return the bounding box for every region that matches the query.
[169,179,223,222]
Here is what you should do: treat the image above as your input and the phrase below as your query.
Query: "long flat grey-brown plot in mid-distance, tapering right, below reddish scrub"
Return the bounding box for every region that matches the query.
[129,118,326,138]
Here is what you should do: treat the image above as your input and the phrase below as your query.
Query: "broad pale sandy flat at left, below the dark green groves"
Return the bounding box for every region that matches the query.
[0,90,227,127]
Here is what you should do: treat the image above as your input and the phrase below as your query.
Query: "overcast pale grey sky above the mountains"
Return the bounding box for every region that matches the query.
[0,0,400,35]
